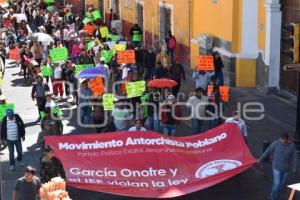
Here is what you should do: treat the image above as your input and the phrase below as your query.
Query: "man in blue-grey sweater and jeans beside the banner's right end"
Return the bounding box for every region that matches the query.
[257,133,297,200]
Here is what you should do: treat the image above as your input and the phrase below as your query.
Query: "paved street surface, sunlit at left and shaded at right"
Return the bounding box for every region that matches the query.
[0,60,299,200]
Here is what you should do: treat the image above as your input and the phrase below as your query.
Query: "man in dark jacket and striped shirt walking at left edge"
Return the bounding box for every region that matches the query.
[1,109,25,171]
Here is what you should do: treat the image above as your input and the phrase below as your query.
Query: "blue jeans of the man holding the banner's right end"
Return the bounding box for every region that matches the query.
[271,168,289,200]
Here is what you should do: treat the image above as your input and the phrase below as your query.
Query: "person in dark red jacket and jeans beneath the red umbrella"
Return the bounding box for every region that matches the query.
[160,95,182,136]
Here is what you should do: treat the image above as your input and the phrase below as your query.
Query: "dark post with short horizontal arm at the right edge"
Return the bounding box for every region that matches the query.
[283,64,300,152]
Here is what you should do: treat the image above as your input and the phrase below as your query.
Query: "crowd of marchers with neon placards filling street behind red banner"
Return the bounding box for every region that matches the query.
[0,0,296,200]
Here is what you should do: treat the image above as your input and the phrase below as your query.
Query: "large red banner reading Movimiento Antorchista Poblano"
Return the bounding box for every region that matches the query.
[45,123,255,198]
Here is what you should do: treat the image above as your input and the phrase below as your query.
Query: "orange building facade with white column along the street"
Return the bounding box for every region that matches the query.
[82,0,300,93]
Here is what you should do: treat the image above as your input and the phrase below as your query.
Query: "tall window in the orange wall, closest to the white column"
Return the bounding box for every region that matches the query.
[159,6,173,40]
